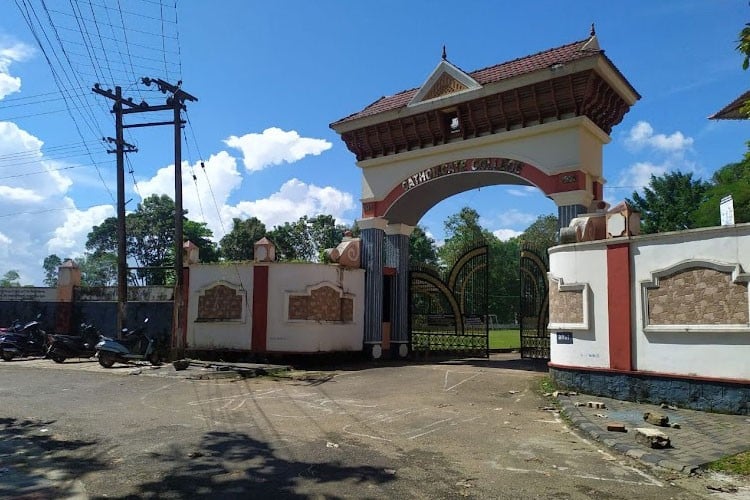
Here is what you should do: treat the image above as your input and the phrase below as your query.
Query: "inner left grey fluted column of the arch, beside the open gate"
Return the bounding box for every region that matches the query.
[385,224,414,358]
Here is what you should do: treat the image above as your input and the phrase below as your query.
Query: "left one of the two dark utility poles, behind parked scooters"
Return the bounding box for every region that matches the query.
[92,84,138,338]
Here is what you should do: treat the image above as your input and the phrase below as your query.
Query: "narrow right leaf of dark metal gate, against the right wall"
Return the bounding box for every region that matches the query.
[519,244,549,359]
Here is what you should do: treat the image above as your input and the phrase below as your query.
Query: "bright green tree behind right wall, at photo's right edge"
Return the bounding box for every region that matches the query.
[695,158,750,227]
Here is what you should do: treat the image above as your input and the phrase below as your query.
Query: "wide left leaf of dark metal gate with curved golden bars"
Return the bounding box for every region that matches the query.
[409,245,489,357]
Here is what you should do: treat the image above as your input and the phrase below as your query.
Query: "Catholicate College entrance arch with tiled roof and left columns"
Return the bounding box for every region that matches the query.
[331,27,640,358]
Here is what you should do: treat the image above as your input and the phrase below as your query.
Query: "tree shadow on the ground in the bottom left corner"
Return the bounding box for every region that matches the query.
[0,418,106,498]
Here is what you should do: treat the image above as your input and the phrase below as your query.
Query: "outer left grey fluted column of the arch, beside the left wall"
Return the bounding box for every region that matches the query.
[357,217,388,359]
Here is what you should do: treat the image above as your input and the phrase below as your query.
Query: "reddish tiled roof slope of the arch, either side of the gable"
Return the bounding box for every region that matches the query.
[333,38,604,125]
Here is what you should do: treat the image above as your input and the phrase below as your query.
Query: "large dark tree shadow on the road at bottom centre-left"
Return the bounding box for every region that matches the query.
[108,432,395,499]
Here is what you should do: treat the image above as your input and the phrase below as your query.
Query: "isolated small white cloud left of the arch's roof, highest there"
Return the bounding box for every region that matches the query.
[224,127,332,172]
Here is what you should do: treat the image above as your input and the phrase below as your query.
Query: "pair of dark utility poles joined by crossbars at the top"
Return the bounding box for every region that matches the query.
[92,77,198,357]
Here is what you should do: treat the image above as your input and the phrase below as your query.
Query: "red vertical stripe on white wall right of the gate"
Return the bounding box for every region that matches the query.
[607,243,632,370]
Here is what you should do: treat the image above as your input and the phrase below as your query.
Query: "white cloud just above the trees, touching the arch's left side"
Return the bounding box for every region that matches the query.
[228,179,356,229]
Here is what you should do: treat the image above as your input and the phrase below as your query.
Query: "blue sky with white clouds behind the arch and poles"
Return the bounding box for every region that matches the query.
[0,0,750,285]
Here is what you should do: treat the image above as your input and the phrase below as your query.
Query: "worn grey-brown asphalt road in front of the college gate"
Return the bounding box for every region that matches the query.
[0,359,740,499]
